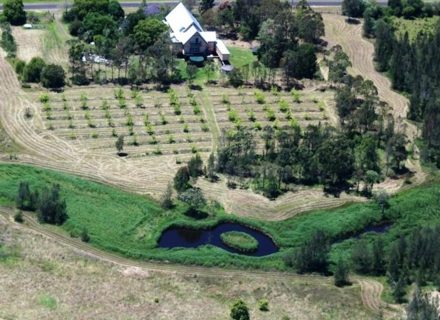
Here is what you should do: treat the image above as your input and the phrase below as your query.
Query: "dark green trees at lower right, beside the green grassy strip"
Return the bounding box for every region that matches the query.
[285,226,440,304]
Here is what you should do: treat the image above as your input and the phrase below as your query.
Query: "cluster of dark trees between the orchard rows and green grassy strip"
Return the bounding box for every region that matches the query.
[215,63,407,198]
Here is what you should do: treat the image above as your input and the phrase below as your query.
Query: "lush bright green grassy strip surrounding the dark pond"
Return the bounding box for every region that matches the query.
[0,165,440,269]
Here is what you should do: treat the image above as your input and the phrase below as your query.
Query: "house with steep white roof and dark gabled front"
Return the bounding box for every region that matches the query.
[164,3,230,63]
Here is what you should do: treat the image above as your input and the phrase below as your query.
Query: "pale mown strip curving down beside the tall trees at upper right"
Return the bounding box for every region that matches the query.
[322,14,426,188]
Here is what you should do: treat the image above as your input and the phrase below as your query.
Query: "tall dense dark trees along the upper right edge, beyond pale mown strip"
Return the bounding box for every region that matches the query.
[350,0,440,167]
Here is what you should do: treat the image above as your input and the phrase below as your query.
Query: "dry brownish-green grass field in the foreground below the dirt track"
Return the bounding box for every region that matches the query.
[0,219,375,320]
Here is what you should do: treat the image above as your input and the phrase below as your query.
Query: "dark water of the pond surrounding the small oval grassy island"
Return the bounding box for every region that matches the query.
[158,222,278,257]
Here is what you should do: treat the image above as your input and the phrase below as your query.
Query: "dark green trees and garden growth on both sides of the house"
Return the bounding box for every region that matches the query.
[58,0,324,87]
